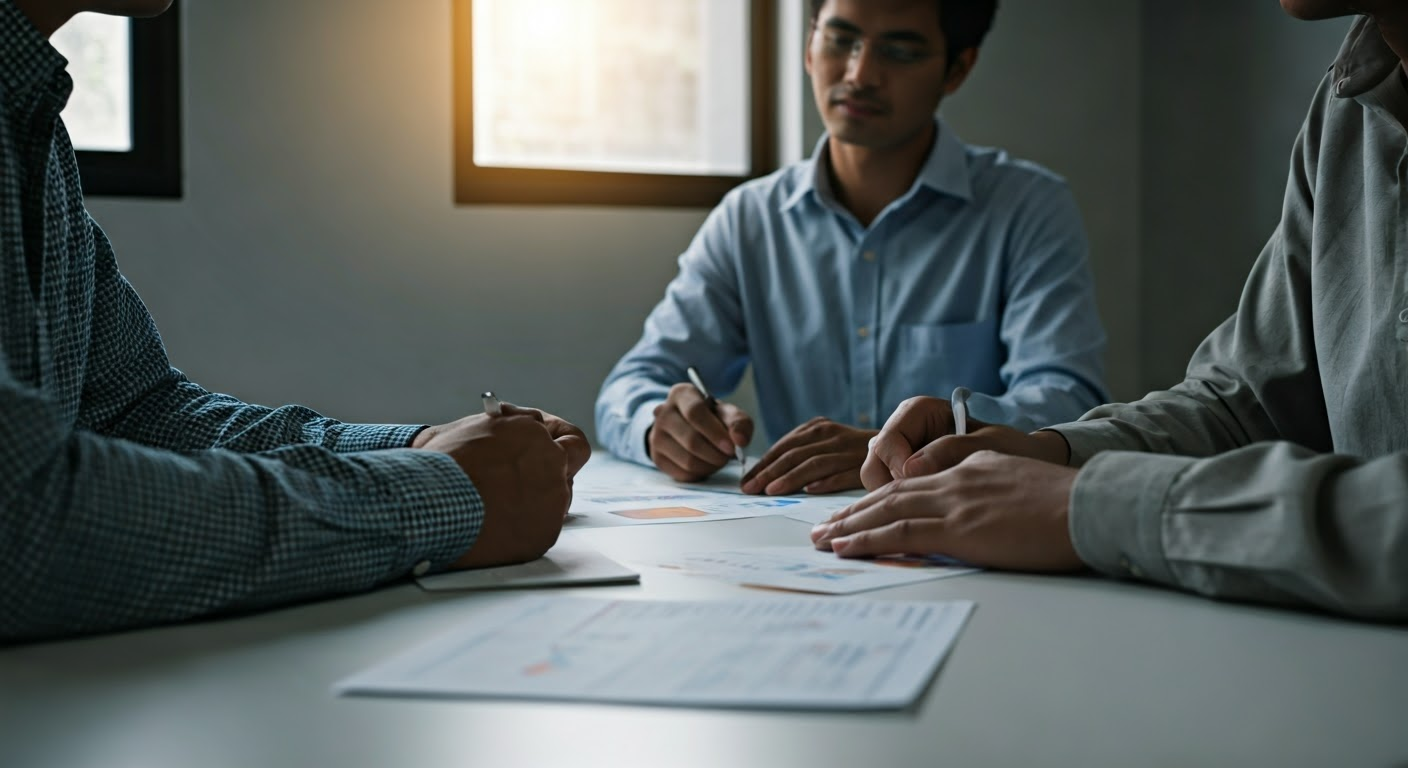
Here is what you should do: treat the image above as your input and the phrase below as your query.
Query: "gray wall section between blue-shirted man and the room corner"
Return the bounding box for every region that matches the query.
[939,0,1140,397]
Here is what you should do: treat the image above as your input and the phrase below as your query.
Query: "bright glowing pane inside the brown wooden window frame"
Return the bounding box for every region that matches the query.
[473,0,752,176]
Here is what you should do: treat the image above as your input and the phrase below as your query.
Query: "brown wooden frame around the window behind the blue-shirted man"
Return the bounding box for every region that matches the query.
[452,0,776,207]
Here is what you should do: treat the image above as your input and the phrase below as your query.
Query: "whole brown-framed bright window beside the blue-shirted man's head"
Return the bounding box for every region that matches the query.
[455,0,774,206]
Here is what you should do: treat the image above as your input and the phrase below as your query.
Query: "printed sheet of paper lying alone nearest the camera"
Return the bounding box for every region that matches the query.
[334,596,973,710]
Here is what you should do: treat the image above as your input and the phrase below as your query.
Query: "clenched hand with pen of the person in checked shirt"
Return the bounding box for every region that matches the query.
[413,404,591,568]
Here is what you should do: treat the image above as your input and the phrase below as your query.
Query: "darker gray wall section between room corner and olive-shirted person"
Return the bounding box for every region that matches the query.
[1139,0,1350,390]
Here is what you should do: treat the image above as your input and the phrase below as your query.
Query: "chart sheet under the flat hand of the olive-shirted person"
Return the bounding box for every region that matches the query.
[652,547,977,595]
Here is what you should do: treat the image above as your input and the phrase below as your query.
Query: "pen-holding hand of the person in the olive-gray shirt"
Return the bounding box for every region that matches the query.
[860,397,1070,490]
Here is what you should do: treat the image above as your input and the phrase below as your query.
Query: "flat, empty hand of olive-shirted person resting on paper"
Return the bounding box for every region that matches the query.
[811,451,1084,571]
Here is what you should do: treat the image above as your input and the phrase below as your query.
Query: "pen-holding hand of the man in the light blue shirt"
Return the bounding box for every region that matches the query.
[646,383,753,482]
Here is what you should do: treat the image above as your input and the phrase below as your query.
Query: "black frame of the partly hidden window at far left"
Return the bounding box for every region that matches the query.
[75,0,184,197]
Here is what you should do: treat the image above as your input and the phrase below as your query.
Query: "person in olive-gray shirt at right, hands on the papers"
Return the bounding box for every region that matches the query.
[812,0,1408,620]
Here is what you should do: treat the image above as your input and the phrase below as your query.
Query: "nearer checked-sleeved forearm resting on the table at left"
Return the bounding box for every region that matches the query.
[0,419,483,641]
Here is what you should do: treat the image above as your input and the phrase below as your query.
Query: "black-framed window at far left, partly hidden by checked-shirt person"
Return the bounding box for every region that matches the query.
[54,4,182,197]
